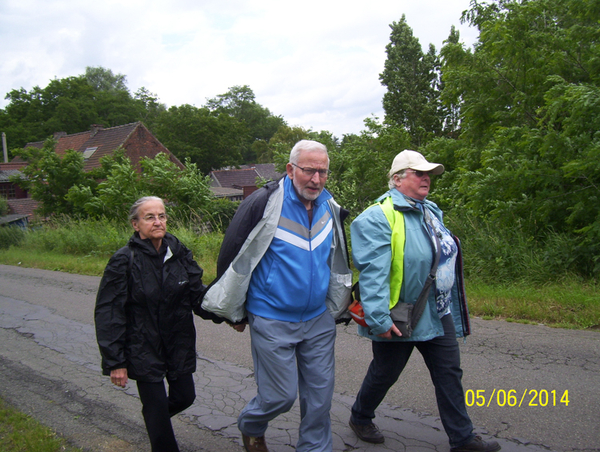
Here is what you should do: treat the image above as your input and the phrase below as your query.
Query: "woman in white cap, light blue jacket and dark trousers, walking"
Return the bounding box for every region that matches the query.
[350,150,500,452]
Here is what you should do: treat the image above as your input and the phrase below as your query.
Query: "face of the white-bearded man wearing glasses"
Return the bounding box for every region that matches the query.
[286,151,329,207]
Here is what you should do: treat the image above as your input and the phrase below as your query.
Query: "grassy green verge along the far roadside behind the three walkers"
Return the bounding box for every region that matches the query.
[0,217,600,329]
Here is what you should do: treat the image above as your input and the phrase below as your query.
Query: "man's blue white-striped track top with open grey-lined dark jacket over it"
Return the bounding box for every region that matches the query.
[202,177,352,322]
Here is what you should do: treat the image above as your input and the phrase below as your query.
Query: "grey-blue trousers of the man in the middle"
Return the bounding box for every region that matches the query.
[238,311,336,452]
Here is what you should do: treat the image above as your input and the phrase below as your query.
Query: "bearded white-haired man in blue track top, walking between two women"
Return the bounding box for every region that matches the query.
[202,140,352,452]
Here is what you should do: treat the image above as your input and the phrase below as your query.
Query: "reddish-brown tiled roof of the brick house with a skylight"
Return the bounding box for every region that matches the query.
[25,122,183,171]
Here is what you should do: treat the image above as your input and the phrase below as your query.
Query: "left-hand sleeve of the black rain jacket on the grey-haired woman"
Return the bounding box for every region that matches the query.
[94,250,130,374]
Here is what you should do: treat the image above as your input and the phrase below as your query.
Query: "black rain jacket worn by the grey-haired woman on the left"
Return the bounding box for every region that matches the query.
[95,232,206,382]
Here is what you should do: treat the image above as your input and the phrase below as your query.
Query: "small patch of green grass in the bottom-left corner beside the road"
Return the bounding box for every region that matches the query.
[0,399,81,452]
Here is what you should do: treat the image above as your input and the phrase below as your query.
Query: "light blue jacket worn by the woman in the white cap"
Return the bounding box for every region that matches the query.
[350,188,470,341]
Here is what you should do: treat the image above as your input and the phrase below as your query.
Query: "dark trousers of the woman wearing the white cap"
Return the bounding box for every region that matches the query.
[352,315,474,447]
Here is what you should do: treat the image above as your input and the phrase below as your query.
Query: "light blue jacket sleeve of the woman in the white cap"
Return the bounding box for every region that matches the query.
[350,205,393,335]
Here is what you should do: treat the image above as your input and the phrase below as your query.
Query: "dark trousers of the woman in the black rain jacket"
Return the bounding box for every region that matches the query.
[137,374,196,452]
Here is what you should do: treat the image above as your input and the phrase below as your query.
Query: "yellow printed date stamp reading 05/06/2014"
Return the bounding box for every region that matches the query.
[465,389,569,407]
